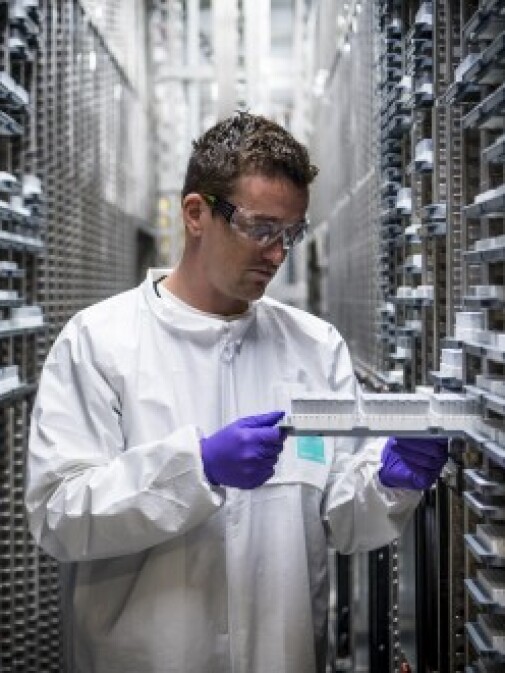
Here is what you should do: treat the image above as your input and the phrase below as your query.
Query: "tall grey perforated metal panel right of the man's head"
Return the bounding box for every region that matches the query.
[311,3,381,380]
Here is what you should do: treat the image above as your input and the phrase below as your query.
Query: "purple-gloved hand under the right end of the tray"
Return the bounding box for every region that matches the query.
[379,437,449,491]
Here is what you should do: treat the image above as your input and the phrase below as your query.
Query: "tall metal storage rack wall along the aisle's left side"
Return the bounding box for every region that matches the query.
[0,0,152,673]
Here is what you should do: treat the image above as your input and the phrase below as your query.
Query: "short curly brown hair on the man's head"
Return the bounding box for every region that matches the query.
[182,112,318,198]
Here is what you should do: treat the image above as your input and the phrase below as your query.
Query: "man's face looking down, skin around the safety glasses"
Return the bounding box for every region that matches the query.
[200,175,308,314]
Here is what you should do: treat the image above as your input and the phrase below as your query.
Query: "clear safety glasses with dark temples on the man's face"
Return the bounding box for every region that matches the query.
[202,194,309,250]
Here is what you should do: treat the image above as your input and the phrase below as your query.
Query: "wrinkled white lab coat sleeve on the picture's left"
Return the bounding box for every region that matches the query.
[25,323,223,561]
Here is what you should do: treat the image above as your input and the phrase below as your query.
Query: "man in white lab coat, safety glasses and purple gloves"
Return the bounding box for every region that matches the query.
[26,113,447,673]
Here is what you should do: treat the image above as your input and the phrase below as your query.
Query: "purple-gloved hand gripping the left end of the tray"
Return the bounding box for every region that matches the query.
[200,411,286,488]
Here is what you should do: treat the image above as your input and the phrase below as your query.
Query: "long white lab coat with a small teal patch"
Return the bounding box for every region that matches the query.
[26,271,420,673]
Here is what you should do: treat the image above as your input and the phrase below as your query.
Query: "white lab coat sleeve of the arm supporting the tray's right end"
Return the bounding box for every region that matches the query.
[323,330,422,554]
